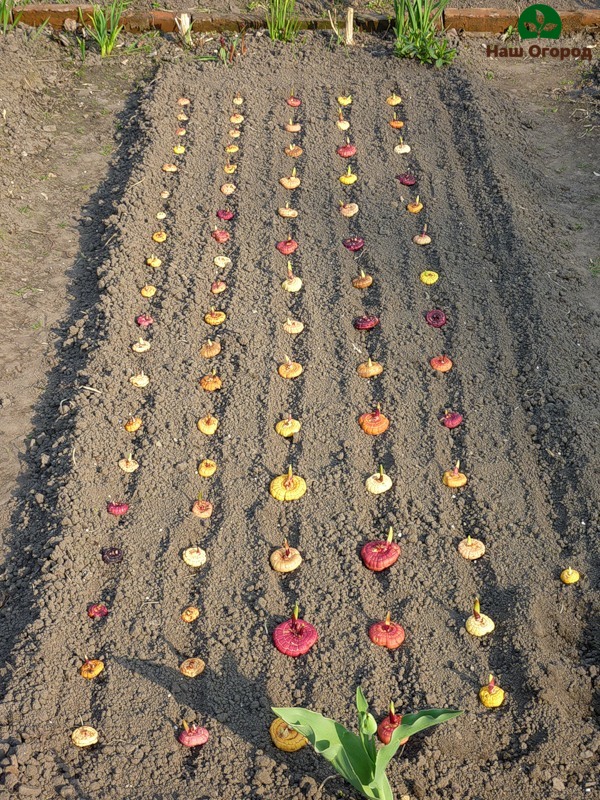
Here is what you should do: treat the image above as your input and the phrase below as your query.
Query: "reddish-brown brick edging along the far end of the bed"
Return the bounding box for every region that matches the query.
[13,4,600,34]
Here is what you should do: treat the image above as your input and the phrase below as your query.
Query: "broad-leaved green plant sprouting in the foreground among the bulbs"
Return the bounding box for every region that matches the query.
[272,686,462,800]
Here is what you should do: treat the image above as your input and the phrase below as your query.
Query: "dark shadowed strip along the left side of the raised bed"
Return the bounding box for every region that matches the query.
[0,73,154,694]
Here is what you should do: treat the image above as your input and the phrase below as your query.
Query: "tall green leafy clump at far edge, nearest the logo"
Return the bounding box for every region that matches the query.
[394,0,456,67]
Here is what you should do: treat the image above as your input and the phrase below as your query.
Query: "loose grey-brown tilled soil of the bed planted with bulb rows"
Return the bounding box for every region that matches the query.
[0,37,599,800]
